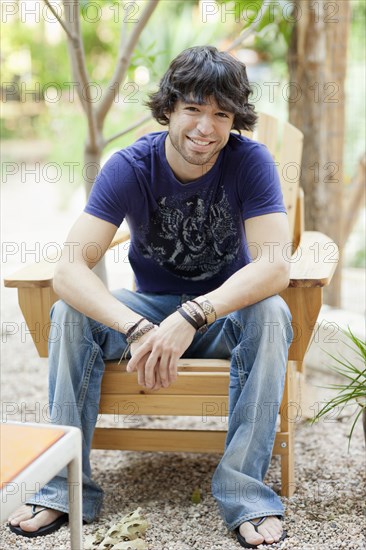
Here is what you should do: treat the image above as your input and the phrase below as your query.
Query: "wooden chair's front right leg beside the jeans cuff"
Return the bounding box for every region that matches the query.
[281,361,297,497]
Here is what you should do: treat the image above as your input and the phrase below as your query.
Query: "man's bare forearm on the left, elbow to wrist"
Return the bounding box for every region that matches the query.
[53,264,141,333]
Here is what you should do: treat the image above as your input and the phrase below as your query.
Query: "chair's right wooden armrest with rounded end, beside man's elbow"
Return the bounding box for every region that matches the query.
[289,231,339,287]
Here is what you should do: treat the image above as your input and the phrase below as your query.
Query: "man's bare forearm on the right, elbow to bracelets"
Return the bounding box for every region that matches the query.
[205,261,289,317]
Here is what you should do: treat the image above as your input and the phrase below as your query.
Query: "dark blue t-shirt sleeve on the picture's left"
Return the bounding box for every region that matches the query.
[84,153,135,227]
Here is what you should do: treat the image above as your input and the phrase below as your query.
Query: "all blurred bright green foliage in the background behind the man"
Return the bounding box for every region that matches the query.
[1,0,366,199]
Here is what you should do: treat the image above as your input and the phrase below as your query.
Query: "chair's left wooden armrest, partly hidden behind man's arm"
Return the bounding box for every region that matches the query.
[4,230,130,288]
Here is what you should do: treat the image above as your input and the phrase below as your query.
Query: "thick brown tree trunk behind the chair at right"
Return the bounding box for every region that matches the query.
[288,0,351,307]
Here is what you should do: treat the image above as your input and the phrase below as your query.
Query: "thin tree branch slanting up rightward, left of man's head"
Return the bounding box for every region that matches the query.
[97,0,159,126]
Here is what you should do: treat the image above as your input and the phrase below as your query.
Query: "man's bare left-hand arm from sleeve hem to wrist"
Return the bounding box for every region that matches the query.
[53,212,141,332]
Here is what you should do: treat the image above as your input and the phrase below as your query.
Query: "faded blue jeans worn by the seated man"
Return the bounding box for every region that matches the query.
[28,289,292,529]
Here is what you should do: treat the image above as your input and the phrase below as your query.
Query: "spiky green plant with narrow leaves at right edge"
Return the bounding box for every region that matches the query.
[311,327,366,448]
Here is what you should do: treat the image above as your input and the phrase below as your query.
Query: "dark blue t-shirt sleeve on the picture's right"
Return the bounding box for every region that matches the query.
[238,143,286,220]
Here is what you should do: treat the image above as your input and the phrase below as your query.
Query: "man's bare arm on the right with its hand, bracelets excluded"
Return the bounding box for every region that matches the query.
[128,213,290,389]
